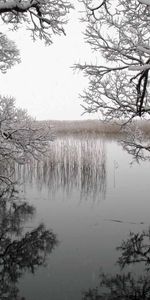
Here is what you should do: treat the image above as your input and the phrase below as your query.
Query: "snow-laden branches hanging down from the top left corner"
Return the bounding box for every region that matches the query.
[0,0,73,44]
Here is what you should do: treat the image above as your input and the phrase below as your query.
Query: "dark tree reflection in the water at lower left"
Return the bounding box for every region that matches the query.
[0,185,57,300]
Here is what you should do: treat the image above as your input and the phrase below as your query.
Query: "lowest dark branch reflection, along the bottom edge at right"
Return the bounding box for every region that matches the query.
[82,273,150,300]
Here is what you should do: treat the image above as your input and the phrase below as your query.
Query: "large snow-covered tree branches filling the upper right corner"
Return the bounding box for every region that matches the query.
[75,0,150,120]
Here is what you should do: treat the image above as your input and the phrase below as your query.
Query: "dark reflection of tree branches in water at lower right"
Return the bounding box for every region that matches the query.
[82,229,150,300]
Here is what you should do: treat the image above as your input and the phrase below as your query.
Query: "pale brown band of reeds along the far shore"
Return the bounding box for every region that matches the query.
[38,120,150,135]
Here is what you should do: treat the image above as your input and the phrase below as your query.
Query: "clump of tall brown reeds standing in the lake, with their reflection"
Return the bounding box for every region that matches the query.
[19,137,106,199]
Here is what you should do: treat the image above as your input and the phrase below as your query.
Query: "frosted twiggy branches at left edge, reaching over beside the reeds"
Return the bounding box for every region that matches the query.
[0,96,54,186]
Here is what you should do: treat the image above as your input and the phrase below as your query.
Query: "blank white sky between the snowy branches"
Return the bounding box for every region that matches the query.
[0,4,97,120]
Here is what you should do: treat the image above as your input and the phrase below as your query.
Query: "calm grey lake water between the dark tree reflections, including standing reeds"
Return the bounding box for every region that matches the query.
[9,136,150,300]
